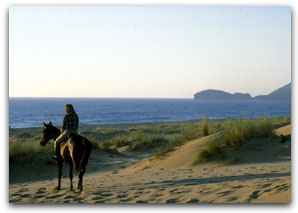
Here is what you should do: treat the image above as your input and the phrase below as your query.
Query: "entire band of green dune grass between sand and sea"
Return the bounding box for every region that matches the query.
[9,115,291,163]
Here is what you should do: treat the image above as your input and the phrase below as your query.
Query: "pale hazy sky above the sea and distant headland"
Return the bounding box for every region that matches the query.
[9,6,291,98]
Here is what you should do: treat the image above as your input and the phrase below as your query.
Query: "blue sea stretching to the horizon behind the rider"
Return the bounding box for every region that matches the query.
[9,98,291,128]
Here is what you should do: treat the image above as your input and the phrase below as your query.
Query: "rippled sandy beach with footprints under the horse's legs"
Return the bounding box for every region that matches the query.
[9,125,291,203]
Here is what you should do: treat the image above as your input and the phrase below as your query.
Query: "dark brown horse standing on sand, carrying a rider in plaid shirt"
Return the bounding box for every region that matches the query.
[40,122,92,192]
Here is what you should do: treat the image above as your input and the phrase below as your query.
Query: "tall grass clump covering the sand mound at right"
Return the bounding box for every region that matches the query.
[193,118,290,165]
